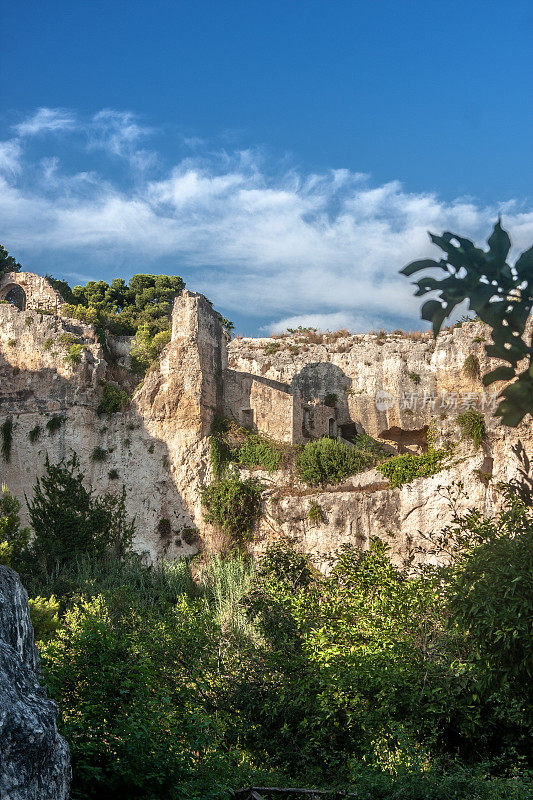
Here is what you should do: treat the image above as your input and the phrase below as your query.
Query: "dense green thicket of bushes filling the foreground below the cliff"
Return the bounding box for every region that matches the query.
[18,478,533,800]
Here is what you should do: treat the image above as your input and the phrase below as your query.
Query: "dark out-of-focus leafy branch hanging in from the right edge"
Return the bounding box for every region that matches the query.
[401,220,533,426]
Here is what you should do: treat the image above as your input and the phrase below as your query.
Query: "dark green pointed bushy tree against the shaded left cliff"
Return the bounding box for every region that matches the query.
[27,456,133,574]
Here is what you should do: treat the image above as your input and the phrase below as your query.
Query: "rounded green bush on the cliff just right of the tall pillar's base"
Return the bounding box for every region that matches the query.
[202,477,262,544]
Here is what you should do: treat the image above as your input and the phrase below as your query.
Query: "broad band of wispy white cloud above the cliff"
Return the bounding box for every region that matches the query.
[0,109,533,329]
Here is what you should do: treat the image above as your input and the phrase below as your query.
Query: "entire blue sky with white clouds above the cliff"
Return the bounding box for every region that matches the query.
[0,0,533,333]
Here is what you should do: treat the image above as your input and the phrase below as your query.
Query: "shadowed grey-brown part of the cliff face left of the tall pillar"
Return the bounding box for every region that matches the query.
[0,352,199,557]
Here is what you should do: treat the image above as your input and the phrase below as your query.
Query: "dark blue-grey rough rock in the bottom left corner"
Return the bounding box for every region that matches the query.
[0,566,70,800]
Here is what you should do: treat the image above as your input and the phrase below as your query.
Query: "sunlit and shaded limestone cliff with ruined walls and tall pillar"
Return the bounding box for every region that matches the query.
[0,273,533,562]
